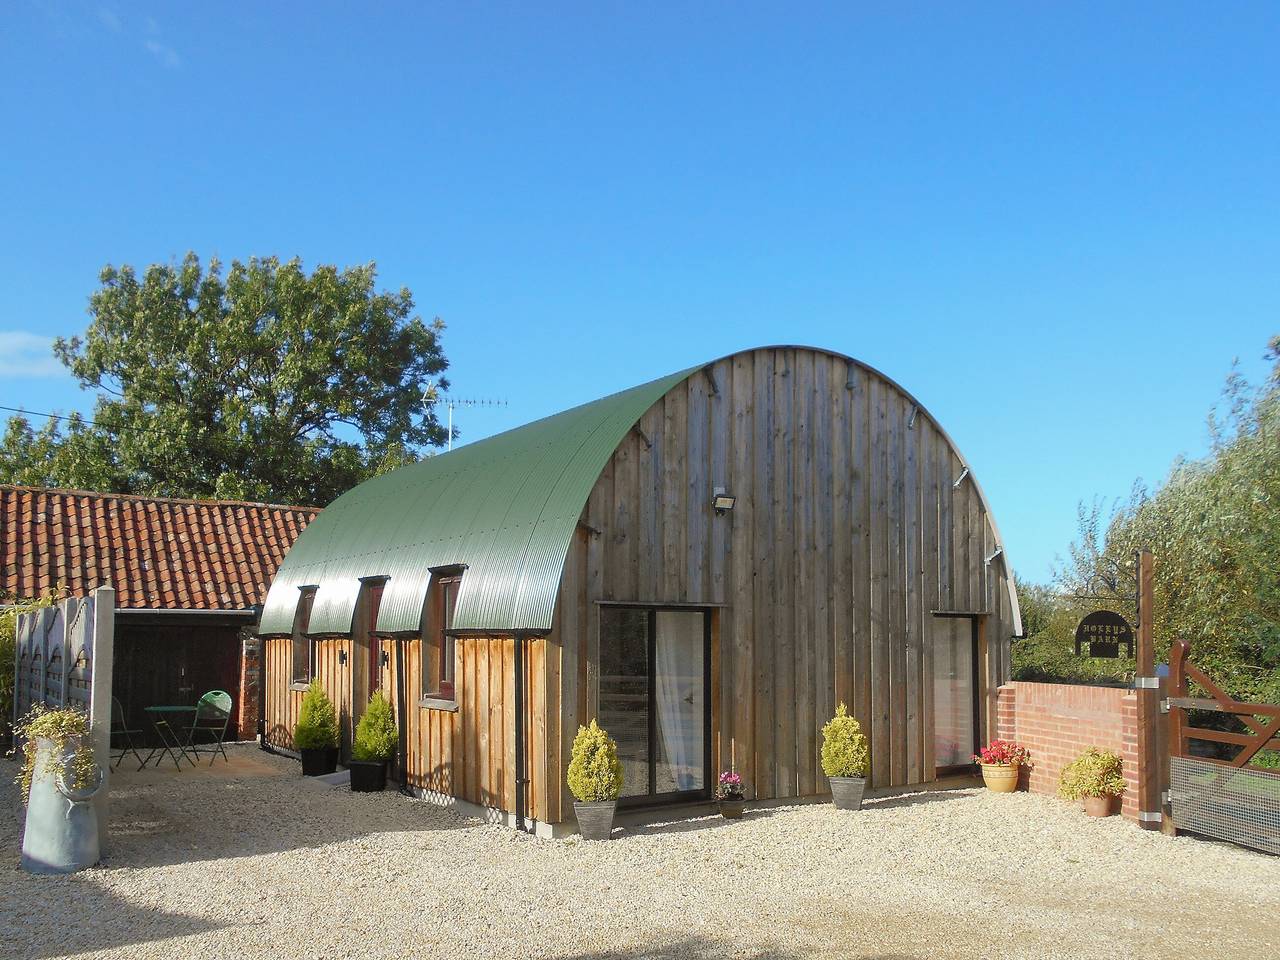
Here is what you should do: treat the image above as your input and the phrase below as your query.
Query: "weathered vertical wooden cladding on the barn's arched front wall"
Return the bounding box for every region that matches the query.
[555,348,1012,803]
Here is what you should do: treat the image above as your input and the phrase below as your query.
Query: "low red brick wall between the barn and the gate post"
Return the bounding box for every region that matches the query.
[996,681,1138,820]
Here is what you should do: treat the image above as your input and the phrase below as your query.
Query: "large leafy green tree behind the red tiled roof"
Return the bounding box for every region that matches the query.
[0,253,448,504]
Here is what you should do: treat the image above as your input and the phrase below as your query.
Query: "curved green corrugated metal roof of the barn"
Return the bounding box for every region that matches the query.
[260,367,699,635]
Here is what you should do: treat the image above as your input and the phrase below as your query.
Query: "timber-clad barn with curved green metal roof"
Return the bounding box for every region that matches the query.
[260,347,1021,831]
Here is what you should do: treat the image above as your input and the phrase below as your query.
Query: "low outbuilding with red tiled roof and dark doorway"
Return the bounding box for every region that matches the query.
[0,485,320,737]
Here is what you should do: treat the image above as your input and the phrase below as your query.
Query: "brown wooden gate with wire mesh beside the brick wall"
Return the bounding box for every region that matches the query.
[1165,640,1280,854]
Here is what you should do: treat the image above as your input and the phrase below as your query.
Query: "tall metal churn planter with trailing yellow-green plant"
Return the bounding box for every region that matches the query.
[15,704,105,873]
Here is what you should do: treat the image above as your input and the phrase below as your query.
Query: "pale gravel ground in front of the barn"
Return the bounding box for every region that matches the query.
[0,746,1280,960]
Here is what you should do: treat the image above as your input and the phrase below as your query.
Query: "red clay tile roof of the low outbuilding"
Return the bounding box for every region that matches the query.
[0,484,320,611]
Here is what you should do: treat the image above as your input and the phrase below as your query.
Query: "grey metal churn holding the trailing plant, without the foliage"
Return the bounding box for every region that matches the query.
[22,737,106,873]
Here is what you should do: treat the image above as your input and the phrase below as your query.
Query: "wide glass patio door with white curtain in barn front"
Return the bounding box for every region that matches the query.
[600,607,710,804]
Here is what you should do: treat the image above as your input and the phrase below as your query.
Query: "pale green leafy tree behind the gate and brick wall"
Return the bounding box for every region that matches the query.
[1014,337,1280,703]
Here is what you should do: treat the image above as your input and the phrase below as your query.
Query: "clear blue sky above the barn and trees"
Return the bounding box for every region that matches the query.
[0,0,1280,579]
